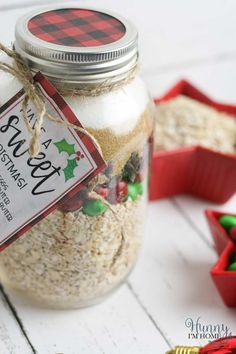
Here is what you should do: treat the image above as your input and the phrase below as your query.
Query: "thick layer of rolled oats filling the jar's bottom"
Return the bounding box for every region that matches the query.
[0,197,145,308]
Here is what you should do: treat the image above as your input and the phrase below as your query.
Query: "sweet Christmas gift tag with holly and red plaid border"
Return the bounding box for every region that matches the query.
[0,73,105,250]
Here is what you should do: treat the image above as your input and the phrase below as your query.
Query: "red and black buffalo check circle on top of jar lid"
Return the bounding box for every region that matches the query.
[28,8,125,47]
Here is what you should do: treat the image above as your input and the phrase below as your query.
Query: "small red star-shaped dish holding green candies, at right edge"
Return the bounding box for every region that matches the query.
[205,209,236,307]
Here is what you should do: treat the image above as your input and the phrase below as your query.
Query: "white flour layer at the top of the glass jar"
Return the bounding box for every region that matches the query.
[0,54,149,135]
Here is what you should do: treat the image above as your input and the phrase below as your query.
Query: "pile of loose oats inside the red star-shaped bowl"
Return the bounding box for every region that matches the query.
[154,96,236,154]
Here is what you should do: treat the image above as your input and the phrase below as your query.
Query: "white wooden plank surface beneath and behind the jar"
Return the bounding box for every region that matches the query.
[0,0,236,354]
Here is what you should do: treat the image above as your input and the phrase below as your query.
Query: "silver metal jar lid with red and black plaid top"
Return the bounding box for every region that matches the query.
[14,7,138,83]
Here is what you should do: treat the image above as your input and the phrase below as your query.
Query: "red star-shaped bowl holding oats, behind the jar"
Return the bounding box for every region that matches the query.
[150,80,236,203]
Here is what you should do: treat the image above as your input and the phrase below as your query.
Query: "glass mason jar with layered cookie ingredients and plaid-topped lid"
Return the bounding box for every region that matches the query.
[0,8,152,308]
